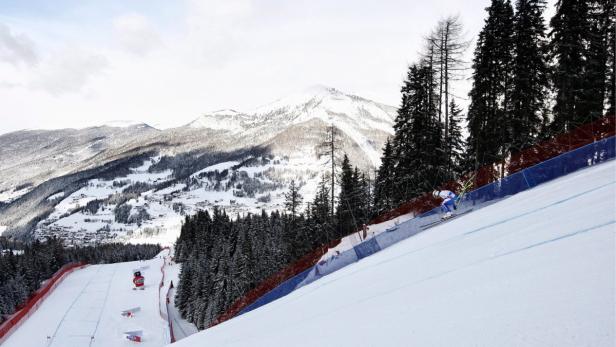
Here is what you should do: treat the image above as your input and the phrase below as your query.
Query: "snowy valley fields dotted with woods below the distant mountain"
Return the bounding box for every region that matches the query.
[33,157,327,246]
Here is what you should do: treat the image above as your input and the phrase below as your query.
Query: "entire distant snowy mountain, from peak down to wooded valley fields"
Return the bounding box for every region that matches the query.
[0,86,396,243]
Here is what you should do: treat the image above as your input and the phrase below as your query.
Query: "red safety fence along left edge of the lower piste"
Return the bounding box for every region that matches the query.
[0,262,87,344]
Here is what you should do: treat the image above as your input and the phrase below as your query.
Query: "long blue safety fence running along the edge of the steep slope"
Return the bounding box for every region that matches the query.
[238,136,616,315]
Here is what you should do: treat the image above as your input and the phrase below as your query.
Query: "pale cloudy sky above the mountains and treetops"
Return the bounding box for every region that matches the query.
[0,0,553,133]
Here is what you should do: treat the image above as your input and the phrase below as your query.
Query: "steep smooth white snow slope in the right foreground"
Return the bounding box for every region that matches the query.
[173,161,616,347]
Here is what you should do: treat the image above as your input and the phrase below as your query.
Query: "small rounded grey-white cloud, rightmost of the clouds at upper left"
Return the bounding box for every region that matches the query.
[113,14,162,55]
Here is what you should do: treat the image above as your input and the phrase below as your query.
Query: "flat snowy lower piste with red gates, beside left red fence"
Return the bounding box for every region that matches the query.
[2,251,169,347]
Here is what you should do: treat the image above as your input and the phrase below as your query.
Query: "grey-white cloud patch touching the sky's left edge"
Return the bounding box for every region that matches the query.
[0,23,38,65]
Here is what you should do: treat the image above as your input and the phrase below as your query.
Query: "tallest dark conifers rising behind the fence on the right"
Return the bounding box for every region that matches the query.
[374,0,616,212]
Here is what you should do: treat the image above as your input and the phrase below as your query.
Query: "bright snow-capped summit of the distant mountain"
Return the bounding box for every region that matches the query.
[188,85,396,168]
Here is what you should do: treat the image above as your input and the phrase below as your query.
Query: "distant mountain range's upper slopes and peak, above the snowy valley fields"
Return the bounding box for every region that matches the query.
[0,86,396,242]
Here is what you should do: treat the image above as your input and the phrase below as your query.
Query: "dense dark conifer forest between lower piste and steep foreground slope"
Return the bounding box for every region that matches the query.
[175,160,372,329]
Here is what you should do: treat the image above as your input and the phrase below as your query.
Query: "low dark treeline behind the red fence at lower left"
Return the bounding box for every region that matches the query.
[0,238,160,323]
